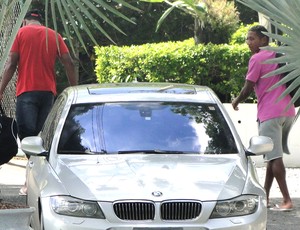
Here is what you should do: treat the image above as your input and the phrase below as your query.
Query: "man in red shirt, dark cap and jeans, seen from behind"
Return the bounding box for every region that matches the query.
[0,10,77,140]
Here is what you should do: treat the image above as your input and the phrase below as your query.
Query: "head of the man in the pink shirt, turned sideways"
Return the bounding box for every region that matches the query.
[246,25,269,54]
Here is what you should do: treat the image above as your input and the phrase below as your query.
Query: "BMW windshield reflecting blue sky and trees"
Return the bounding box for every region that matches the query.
[58,102,237,154]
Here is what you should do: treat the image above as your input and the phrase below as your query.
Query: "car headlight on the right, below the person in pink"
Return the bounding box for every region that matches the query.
[210,195,258,219]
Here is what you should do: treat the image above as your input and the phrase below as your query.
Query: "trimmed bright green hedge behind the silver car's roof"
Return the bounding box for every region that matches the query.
[95,39,250,102]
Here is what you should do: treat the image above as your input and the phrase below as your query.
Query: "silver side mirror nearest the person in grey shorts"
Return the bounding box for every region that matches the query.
[247,136,274,156]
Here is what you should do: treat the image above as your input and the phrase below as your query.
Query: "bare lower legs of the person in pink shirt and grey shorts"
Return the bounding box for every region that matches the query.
[265,158,293,208]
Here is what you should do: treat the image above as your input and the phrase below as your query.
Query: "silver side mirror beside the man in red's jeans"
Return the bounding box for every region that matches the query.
[21,136,47,156]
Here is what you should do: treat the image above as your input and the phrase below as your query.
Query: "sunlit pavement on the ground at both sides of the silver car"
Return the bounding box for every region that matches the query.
[0,156,300,230]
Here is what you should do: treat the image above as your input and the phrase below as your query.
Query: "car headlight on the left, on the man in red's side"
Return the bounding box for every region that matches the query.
[50,196,105,219]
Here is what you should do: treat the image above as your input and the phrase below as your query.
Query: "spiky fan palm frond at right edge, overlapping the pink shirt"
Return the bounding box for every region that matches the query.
[237,0,300,111]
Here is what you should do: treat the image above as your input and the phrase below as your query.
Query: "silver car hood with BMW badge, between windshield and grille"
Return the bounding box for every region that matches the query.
[55,154,246,201]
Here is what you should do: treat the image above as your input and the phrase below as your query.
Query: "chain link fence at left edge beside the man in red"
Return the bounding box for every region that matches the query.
[0,1,22,117]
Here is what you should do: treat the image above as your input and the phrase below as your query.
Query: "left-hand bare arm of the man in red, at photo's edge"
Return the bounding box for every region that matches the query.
[0,52,19,100]
